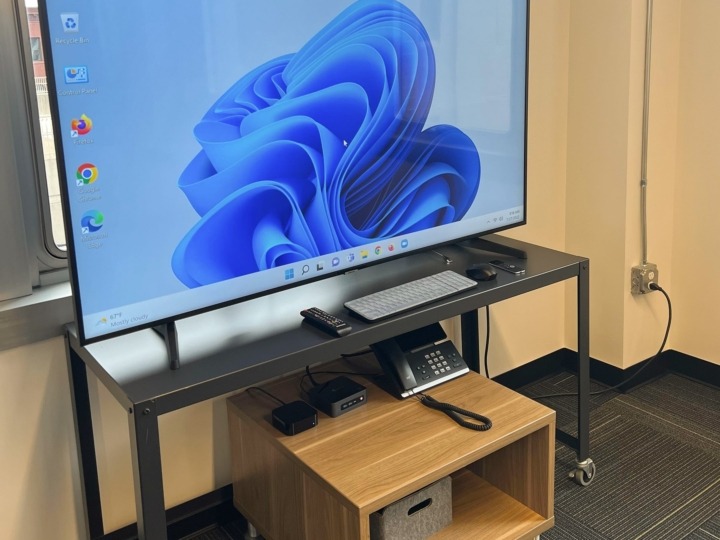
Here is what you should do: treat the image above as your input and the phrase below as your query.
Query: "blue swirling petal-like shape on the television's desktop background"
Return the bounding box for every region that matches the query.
[172,0,480,287]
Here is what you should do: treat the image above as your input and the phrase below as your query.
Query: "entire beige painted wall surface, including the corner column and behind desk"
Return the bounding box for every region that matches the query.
[0,0,720,540]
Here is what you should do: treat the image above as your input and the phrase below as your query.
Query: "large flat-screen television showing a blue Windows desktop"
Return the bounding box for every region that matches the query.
[40,0,528,344]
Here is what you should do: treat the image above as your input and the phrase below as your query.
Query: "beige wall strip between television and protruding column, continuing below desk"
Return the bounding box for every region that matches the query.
[480,0,572,377]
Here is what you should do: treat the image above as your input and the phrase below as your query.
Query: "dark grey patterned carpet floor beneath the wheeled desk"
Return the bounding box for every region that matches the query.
[192,373,720,540]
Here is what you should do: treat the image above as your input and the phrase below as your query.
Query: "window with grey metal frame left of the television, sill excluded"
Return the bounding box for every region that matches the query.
[0,0,67,301]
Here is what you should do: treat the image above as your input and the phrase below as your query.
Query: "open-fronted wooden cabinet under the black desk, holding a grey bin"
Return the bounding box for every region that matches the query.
[228,372,555,540]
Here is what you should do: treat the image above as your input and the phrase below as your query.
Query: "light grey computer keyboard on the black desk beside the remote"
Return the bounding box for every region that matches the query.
[345,270,477,321]
